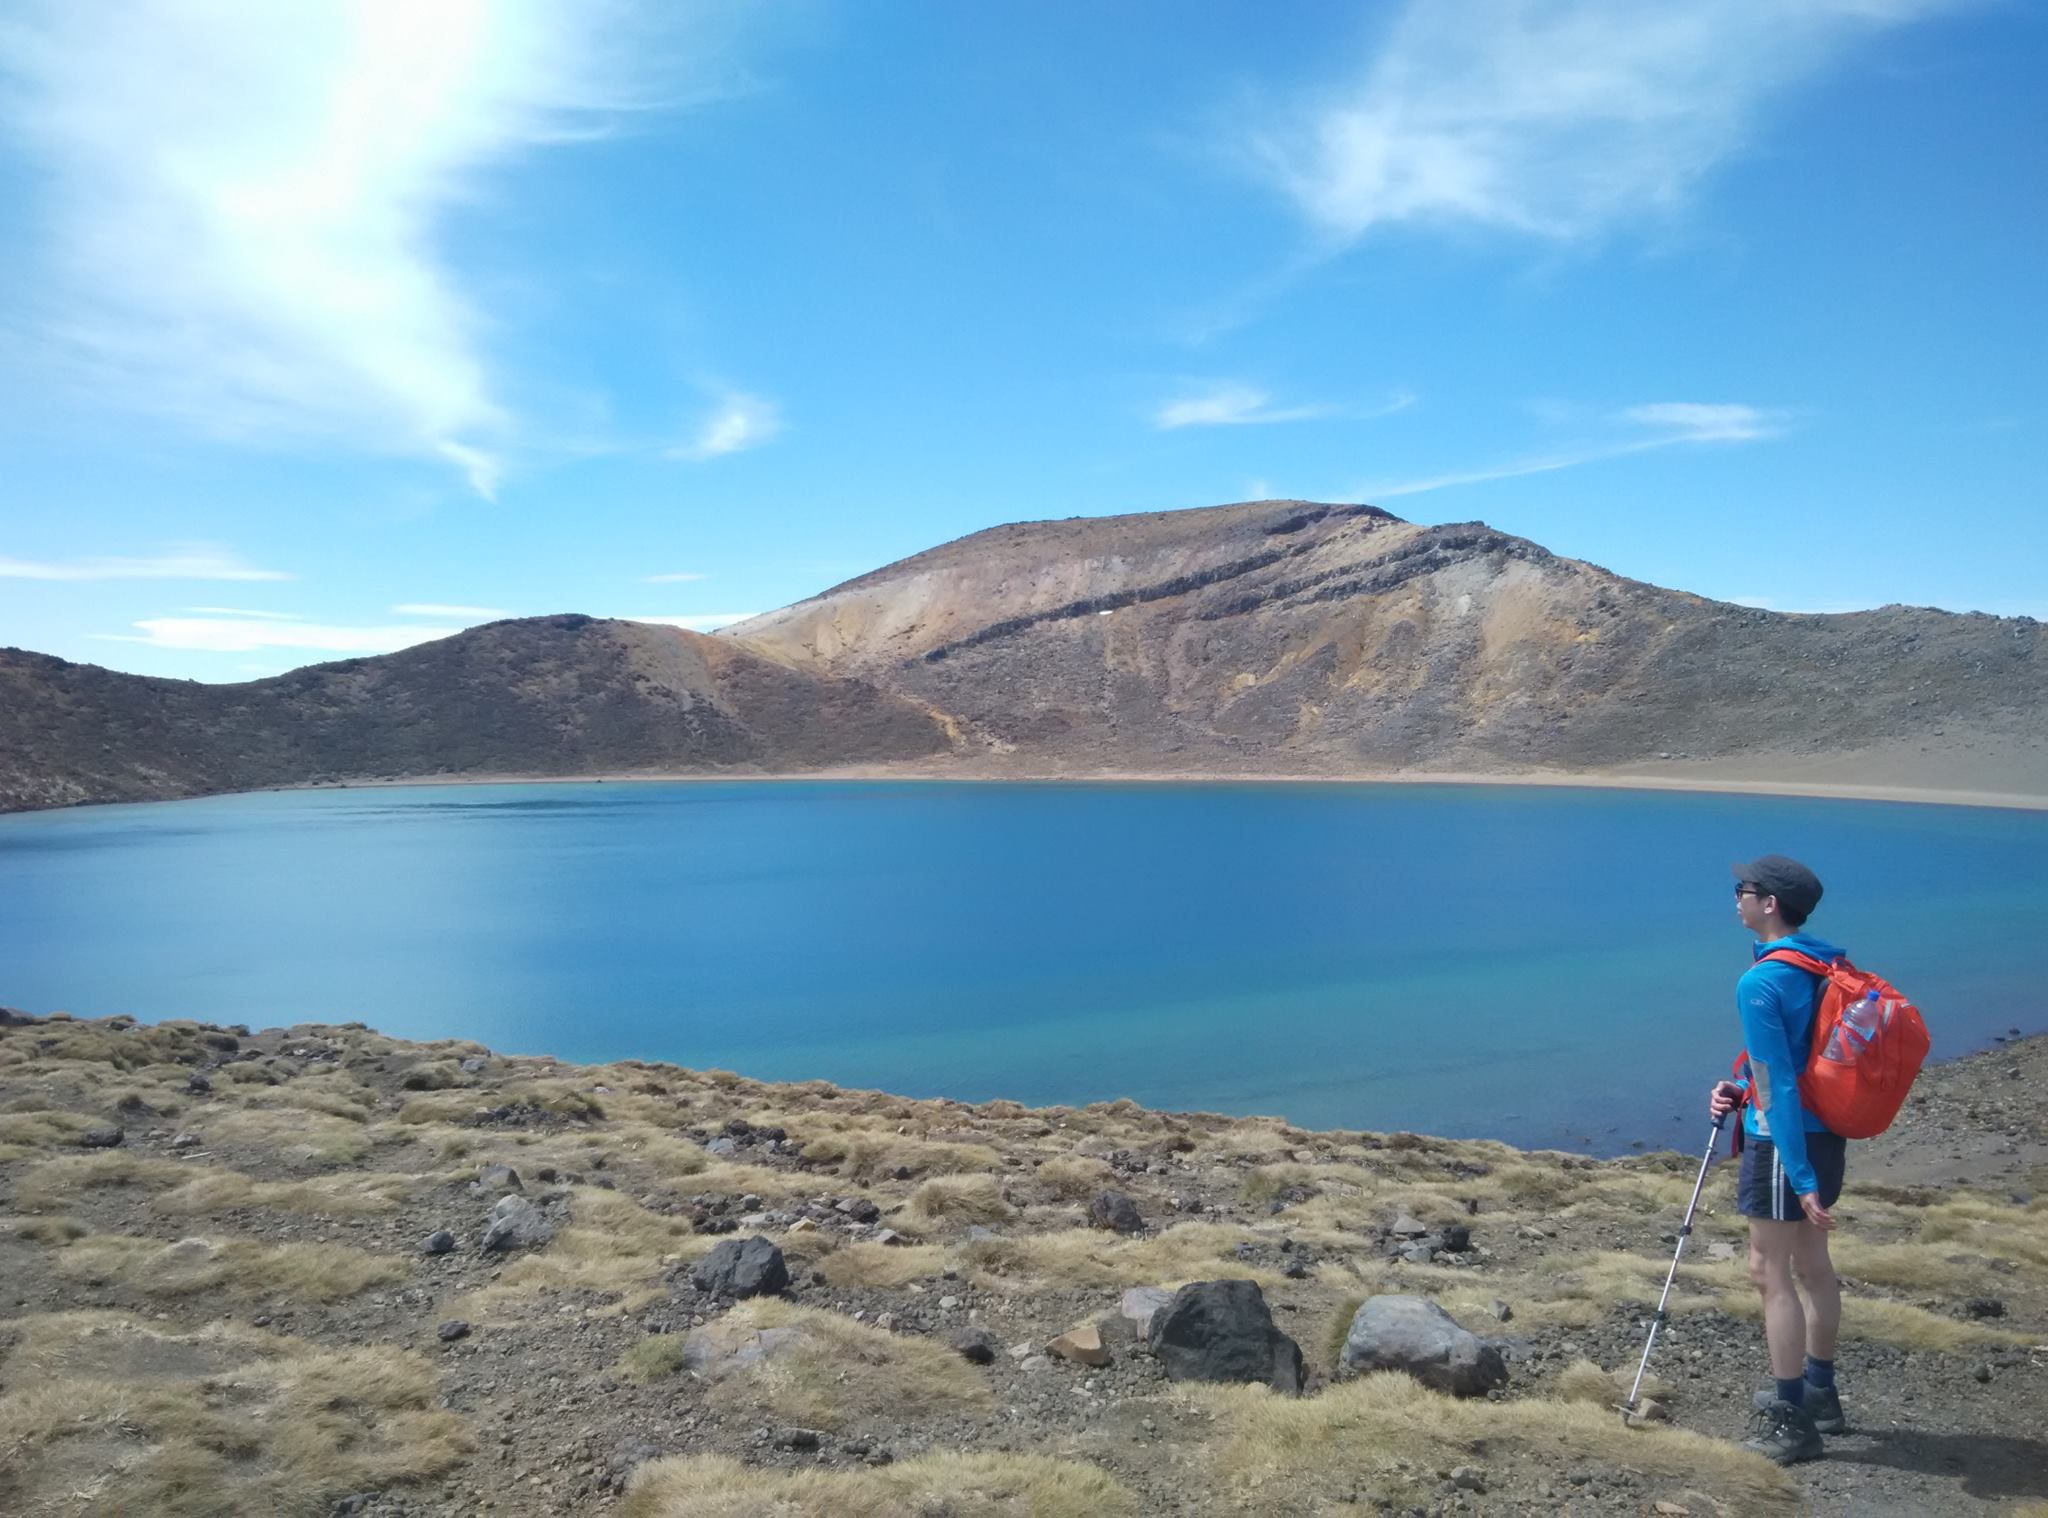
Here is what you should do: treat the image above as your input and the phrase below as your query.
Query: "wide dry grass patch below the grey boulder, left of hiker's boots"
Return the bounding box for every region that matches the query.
[1176,1373,1800,1514]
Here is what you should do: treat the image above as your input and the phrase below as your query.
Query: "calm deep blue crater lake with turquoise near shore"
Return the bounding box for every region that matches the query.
[0,783,2048,1151]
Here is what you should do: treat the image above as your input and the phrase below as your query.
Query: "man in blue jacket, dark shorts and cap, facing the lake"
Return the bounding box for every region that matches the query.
[1710,854,1847,1465]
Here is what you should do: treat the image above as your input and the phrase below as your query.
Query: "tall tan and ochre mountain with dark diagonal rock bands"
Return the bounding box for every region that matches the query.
[727,502,2048,791]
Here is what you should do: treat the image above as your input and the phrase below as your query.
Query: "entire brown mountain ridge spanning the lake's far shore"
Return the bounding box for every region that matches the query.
[0,502,2048,809]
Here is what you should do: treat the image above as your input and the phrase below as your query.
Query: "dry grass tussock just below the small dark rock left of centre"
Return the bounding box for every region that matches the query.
[705,1297,993,1428]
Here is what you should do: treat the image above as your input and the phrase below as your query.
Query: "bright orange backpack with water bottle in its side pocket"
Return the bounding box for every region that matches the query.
[1737,948,1927,1139]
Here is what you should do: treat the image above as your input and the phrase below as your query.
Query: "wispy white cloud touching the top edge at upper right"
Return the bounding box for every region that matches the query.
[1249,0,1966,246]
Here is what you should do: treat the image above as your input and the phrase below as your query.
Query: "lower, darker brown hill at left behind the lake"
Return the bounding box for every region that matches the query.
[0,617,946,811]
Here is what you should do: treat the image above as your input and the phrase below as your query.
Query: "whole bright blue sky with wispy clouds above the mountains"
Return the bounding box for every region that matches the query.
[0,0,2048,680]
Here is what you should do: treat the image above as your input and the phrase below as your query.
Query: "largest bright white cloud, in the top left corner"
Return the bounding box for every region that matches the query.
[0,0,708,496]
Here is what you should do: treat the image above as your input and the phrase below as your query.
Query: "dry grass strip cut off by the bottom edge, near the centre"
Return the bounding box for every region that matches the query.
[618,1454,1139,1518]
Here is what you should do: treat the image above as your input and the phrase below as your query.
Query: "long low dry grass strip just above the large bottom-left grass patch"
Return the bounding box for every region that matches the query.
[51,1233,406,1303]
